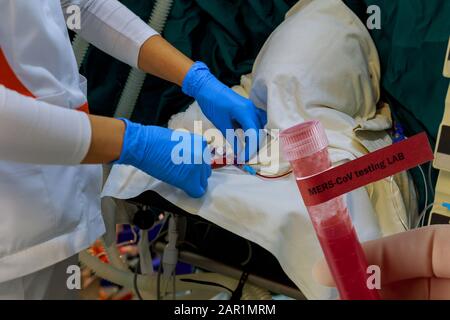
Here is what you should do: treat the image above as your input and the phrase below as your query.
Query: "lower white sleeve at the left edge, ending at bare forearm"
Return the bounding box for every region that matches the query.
[0,85,91,165]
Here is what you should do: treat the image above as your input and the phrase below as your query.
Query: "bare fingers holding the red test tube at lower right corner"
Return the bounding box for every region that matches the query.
[313,225,450,300]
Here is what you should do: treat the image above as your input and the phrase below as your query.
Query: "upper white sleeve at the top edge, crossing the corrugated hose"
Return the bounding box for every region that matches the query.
[61,0,158,68]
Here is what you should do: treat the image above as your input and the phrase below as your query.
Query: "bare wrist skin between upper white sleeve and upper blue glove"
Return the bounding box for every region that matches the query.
[138,36,194,86]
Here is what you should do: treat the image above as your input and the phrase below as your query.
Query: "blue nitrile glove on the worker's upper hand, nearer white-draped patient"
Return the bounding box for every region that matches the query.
[183,62,267,161]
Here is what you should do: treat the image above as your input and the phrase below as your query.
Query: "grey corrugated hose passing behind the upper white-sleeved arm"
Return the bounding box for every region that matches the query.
[114,0,173,119]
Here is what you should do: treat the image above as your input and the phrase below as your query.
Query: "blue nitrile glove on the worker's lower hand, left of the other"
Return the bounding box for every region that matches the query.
[114,119,211,198]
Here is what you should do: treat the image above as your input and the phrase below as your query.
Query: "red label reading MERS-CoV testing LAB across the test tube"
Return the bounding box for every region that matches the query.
[297,133,434,206]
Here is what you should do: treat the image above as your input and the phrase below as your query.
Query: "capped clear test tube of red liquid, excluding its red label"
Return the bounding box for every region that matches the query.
[280,121,379,300]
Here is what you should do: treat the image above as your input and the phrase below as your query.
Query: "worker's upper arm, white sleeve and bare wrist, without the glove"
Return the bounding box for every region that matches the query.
[61,0,193,85]
